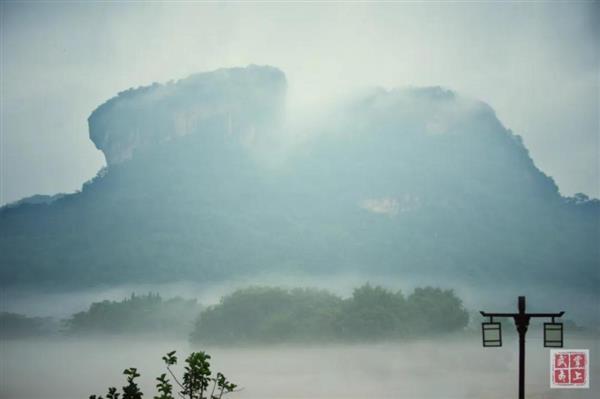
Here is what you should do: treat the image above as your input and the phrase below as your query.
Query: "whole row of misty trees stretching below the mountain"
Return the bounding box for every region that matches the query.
[0,284,469,344]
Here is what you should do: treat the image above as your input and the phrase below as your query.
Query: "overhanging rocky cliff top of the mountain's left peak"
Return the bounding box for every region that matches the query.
[88,66,286,166]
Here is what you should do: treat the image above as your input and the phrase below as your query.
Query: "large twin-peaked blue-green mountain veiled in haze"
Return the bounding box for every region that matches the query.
[0,66,600,318]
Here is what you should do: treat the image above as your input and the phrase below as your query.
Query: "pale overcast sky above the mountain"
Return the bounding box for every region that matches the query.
[0,0,600,204]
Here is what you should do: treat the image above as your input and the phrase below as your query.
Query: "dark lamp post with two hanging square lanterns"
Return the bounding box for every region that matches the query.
[479,296,565,399]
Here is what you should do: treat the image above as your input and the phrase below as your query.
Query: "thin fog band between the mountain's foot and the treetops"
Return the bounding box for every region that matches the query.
[5,273,600,328]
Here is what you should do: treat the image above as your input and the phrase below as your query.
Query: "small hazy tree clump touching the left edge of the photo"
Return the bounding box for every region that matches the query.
[0,312,58,339]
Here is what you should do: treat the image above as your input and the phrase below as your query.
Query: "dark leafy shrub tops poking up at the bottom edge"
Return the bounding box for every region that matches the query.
[90,351,237,399]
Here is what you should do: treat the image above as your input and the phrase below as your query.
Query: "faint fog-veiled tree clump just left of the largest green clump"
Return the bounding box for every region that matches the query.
[65,294,202,336]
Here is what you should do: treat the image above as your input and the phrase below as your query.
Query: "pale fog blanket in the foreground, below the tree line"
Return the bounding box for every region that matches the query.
[0,333,600,399]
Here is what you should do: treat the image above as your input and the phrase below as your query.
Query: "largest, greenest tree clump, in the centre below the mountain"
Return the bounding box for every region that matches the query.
[192,284,469,344]
